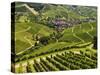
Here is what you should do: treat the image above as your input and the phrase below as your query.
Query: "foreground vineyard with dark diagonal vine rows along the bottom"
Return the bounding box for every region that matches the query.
[16,50,97,73]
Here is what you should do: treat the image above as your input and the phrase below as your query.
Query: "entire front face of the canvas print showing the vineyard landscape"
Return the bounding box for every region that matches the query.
[11,2,97,73]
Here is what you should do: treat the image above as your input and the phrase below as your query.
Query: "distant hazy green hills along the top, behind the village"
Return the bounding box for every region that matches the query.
[16,3,97,21]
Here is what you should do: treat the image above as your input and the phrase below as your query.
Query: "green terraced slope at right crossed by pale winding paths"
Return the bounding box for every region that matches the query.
[59,22,97,43]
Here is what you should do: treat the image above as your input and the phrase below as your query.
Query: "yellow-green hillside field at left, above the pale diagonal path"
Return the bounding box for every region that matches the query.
[15,23,54,53]
